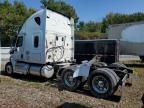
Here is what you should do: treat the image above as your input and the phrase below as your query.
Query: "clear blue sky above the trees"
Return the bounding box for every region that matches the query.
[10,0,144,22]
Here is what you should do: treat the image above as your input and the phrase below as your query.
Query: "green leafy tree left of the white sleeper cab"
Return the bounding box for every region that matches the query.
[0,0,35,46]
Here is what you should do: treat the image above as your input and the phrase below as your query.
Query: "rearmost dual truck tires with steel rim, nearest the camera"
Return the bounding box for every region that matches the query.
[88,68,118,98]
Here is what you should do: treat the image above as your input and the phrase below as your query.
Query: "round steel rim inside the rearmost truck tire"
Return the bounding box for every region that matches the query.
[92,75,109,94]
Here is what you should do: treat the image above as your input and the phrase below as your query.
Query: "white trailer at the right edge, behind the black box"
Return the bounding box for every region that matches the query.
[107,21,144,60]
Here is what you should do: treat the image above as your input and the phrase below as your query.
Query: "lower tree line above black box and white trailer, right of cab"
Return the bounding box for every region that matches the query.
[76,12,144,39]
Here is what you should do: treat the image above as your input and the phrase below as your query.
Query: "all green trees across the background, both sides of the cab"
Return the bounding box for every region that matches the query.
[0,0,144,46]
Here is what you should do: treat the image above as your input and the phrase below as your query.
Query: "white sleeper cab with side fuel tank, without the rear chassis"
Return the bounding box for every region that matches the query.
[6,9,74,78]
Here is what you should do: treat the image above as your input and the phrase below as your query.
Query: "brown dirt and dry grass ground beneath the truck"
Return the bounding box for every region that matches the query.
[0,63,144,108]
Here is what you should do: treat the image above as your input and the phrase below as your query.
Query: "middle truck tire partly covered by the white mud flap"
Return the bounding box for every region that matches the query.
[61,69,81,91]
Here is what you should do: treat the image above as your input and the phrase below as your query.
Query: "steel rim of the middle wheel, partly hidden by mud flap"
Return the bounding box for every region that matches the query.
[64,72,76,87]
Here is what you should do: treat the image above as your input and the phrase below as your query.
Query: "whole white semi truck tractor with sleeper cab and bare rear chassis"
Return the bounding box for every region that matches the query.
[5,9,133,97]
